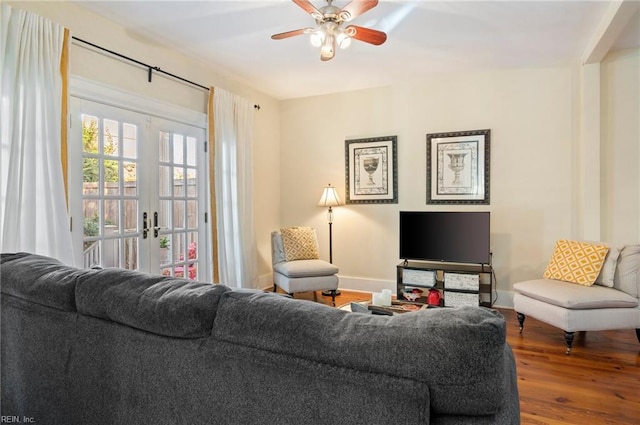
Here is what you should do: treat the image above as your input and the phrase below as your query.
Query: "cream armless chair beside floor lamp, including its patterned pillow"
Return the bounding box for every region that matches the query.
[271,227,338,305]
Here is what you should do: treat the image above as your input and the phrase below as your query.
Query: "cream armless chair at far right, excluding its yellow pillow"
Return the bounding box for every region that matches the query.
[513,245,640,354]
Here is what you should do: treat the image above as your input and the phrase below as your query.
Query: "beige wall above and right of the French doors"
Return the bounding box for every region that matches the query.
[7,1,280,280]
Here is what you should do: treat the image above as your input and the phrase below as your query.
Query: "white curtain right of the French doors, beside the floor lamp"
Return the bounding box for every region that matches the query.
[214,88,258,288]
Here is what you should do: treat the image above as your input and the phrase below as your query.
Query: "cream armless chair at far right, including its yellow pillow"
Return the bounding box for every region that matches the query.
[513,241,640,354]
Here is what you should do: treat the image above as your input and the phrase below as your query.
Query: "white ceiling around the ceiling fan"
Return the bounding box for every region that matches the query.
[78,0,640,99]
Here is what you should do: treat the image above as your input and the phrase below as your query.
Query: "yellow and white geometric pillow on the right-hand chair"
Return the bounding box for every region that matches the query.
[542,240,609,286]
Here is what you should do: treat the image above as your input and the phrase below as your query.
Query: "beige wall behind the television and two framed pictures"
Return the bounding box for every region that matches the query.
[281,51,640,305]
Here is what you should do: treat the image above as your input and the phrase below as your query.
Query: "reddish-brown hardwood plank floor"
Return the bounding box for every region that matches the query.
[295,291,640,425]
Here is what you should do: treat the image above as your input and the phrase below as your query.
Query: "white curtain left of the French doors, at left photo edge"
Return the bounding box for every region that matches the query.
[0,4,74,265]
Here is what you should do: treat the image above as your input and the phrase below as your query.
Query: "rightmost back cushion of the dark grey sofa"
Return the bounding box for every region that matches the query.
[212,291,507,415]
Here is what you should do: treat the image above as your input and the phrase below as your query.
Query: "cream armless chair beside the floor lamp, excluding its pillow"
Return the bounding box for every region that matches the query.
[271,230,338,306]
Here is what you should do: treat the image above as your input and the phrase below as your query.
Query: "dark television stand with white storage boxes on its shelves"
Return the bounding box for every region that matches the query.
[396,260,495,307]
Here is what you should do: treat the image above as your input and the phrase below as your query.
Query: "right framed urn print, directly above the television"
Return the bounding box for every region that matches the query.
[426,129,491,205]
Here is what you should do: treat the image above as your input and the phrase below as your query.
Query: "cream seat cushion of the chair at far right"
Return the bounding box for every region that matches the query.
[513,279,638,310]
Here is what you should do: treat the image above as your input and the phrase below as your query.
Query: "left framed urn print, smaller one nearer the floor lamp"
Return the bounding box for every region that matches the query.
[345,136,398,204]
